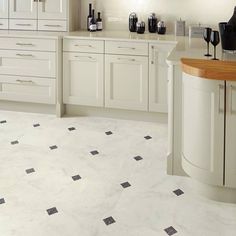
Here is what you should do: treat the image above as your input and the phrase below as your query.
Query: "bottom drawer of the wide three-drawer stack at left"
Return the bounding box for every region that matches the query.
[0,75,56,104]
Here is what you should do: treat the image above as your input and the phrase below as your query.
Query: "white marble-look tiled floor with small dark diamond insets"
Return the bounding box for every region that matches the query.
[0,111,236,236]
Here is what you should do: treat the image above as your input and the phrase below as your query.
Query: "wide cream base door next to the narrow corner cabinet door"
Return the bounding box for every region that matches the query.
[105,55,148,111]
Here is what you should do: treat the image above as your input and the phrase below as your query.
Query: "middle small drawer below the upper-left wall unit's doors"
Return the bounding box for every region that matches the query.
[9,19,37,30]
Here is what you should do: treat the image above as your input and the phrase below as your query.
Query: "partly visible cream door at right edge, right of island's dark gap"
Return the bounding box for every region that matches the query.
[225,82,236,188]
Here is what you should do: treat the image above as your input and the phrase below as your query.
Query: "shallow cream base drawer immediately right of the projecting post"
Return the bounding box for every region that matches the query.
[63,39,104,53]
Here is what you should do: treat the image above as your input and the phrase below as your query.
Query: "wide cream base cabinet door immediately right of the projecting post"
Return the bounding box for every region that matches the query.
[63,52,104,106]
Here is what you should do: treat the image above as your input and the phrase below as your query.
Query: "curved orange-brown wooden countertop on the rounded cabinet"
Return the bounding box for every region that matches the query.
[181,58,236,81]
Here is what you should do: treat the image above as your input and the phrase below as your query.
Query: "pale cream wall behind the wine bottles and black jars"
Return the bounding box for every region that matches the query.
[81,0,236,33]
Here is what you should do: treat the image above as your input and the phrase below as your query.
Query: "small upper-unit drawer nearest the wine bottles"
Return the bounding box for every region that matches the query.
[38,20,67,31]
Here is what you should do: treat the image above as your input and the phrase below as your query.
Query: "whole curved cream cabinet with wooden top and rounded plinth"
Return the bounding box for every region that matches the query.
[181,58,236,203]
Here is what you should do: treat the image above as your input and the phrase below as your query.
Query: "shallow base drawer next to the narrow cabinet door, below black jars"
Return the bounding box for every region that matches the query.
[105,41,148,56]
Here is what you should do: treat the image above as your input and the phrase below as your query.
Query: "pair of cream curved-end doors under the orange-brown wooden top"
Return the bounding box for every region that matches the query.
[182,73,236,188]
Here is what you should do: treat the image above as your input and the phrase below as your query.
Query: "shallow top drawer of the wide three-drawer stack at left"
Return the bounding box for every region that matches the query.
[0,37,56,52]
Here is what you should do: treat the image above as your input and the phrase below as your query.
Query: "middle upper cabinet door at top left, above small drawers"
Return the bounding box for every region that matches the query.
[9,0,38,19]
